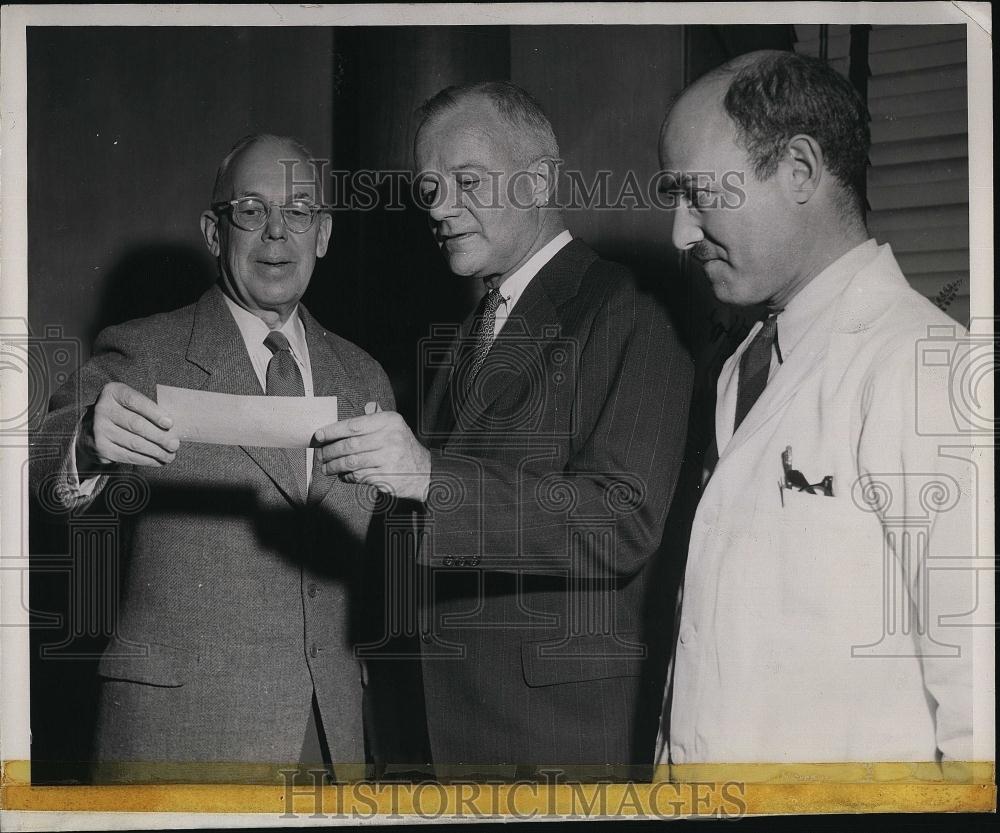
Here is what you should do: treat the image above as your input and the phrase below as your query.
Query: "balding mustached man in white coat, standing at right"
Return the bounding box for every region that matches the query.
[657,52,993,779]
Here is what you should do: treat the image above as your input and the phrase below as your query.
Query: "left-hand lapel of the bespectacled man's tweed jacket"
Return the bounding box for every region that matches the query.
[187,286,304,504]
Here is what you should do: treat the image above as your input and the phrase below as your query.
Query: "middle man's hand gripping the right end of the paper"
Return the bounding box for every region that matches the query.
[314,403,431,501]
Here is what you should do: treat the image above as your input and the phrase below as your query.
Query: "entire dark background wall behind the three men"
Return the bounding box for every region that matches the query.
[28,26,791,782]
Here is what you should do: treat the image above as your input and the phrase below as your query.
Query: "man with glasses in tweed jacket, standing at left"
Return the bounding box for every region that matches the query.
[32,136,394,782]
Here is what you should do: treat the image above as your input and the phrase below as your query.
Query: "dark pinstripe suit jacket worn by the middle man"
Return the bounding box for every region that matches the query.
[420,240,692,772]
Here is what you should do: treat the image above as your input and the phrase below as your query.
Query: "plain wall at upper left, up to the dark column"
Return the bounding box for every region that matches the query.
[28,27,334,356]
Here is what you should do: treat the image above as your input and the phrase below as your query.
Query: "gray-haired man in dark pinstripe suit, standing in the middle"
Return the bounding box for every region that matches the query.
[321,82,691,777]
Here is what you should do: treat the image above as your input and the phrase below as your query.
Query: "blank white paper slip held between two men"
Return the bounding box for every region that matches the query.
[156,385,337,448]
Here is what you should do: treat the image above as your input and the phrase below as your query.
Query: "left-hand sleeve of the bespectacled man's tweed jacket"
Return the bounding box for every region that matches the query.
[30,325,153,509]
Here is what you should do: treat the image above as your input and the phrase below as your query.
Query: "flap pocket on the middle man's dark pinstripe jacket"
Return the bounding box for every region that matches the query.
[521,632,646,688]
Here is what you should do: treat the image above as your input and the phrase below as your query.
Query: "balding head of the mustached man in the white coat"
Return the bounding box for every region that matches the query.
[660,52,868,309]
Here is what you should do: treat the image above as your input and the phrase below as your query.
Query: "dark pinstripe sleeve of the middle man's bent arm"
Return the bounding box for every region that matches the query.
[427,281,693,579]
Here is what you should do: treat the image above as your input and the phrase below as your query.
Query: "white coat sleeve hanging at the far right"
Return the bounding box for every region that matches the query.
[858,341,980,761]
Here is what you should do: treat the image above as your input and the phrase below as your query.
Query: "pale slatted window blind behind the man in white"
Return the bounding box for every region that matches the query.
[795,25,969,323]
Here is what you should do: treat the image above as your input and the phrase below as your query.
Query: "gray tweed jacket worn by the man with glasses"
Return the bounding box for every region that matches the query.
[31,287,394,783]
